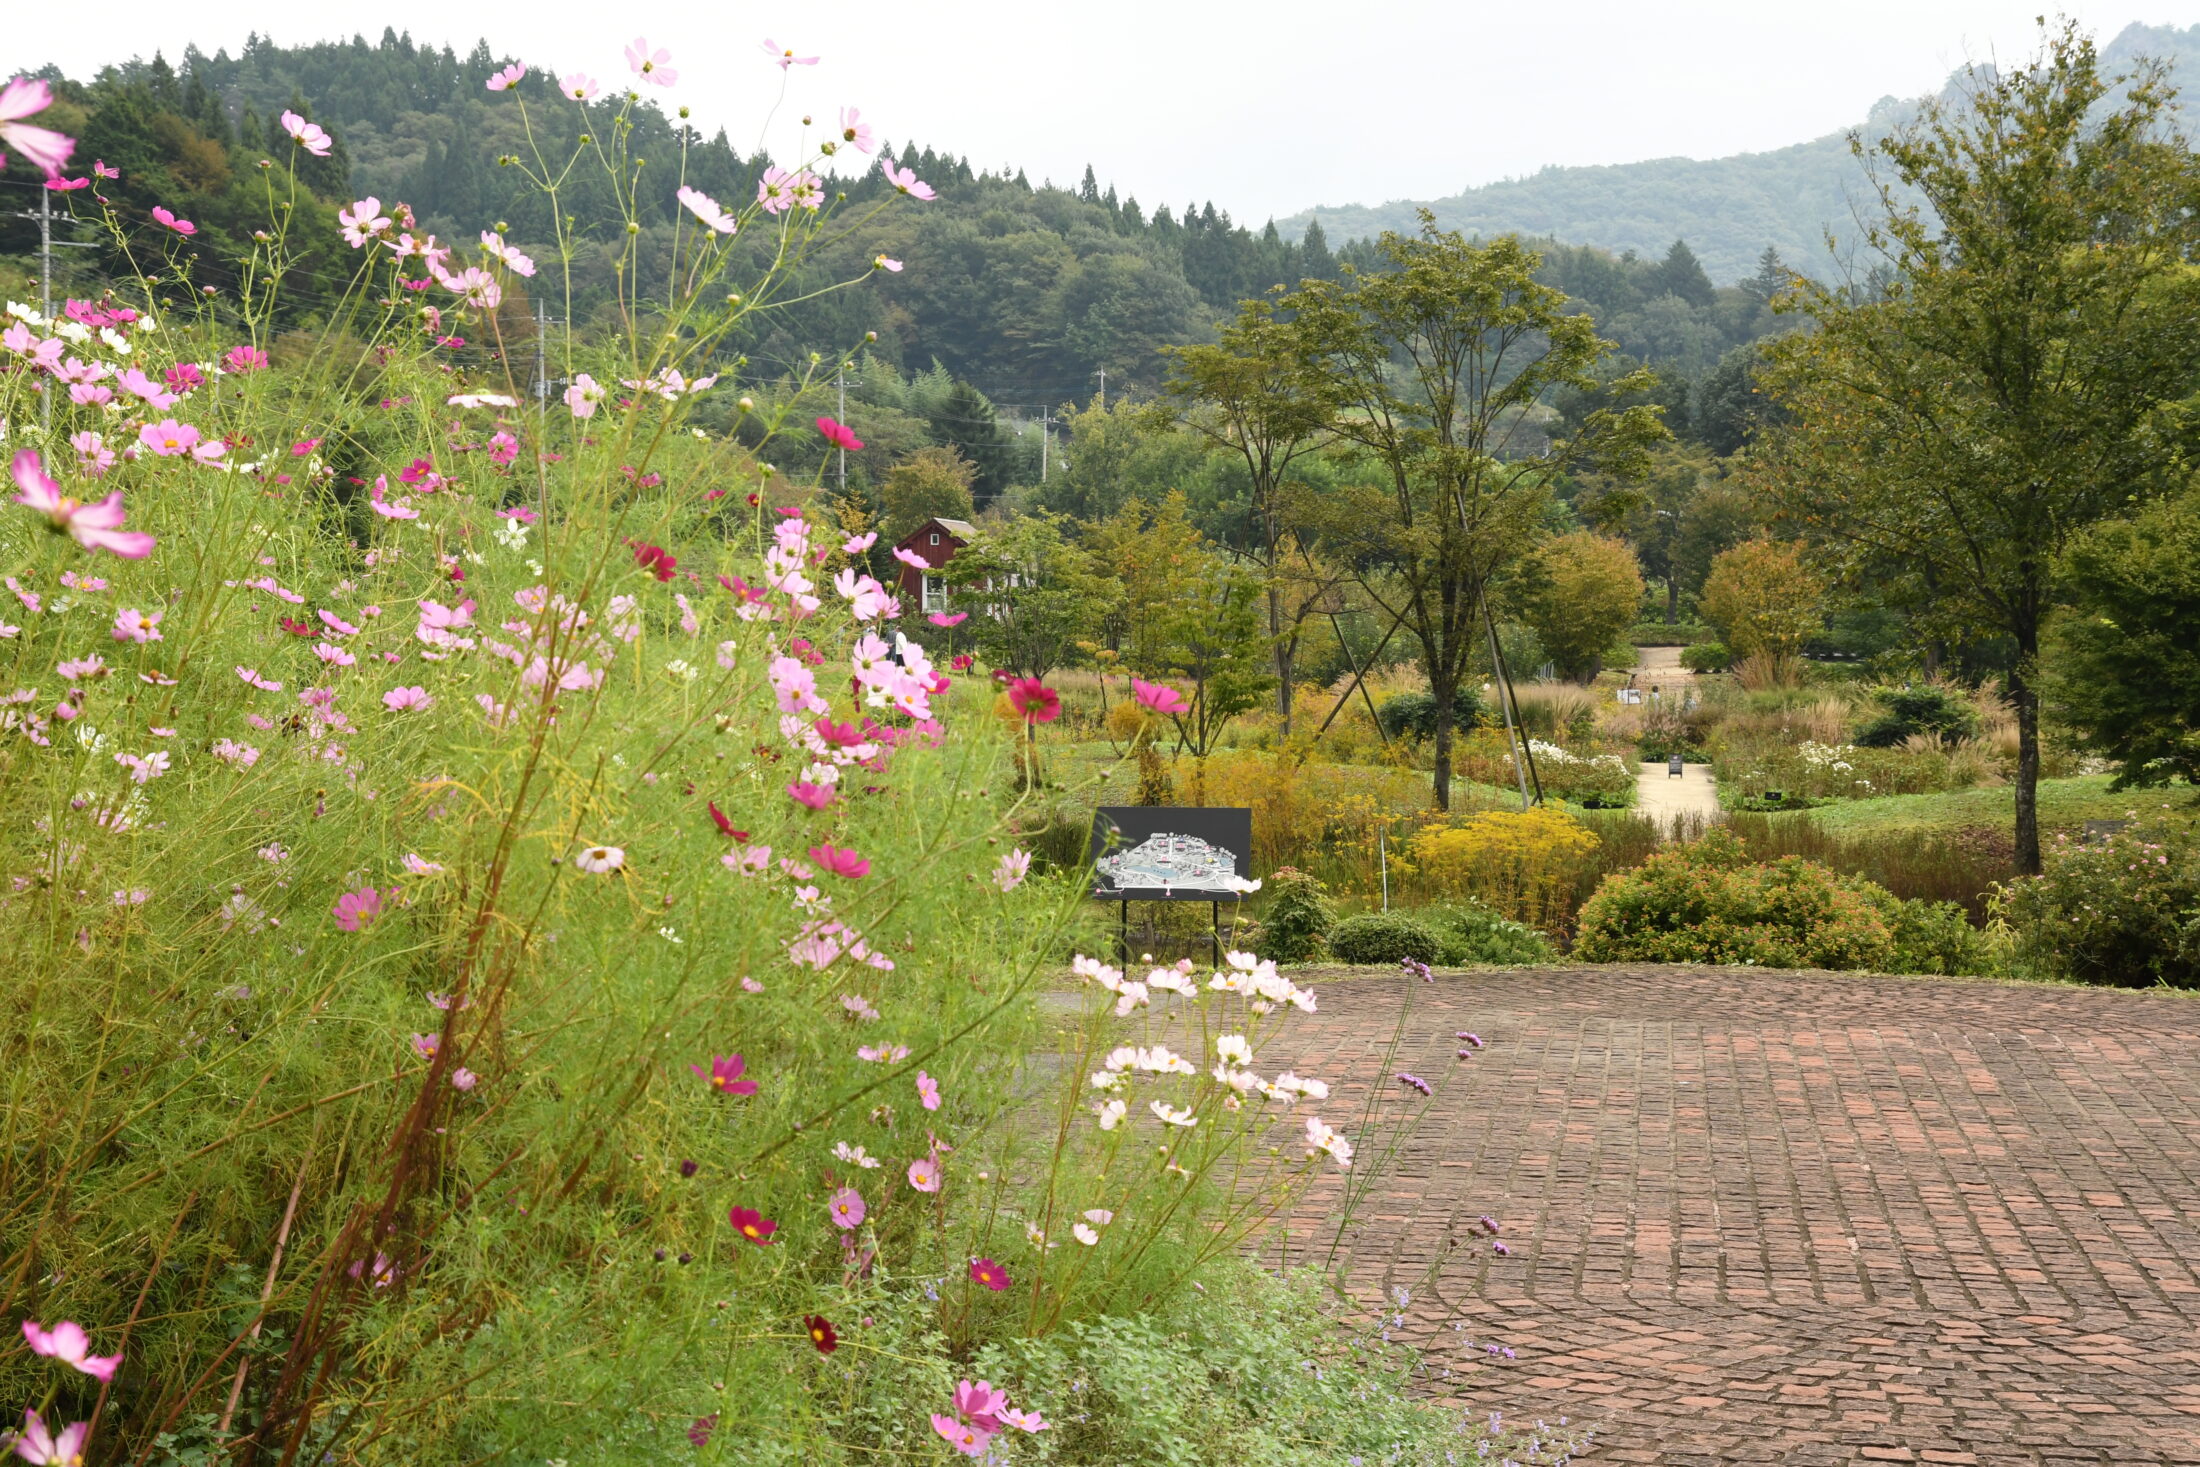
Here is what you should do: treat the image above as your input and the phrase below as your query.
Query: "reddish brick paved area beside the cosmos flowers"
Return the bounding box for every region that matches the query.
[1263,968,2200,1467]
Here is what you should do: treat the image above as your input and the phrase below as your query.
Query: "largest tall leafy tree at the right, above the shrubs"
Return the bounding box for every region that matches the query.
[1758,24,2200,871]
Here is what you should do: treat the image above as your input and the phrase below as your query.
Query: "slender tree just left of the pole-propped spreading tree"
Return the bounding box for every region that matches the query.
[1168,299,1335,735]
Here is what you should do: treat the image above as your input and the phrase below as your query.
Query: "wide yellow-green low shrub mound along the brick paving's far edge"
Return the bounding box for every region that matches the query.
[1573,829,1984,972]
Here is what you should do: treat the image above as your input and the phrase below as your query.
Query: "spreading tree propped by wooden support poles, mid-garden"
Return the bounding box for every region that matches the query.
[1283,224,1665,809]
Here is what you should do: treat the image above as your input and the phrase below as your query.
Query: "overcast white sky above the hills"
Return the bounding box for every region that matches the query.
[0,0,2200,222]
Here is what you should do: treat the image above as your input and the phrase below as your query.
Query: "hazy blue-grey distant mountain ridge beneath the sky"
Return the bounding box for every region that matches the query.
[1276,22,2200,282]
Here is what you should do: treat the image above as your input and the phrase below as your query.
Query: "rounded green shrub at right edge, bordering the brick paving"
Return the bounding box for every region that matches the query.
[1993,818,2200,988]
